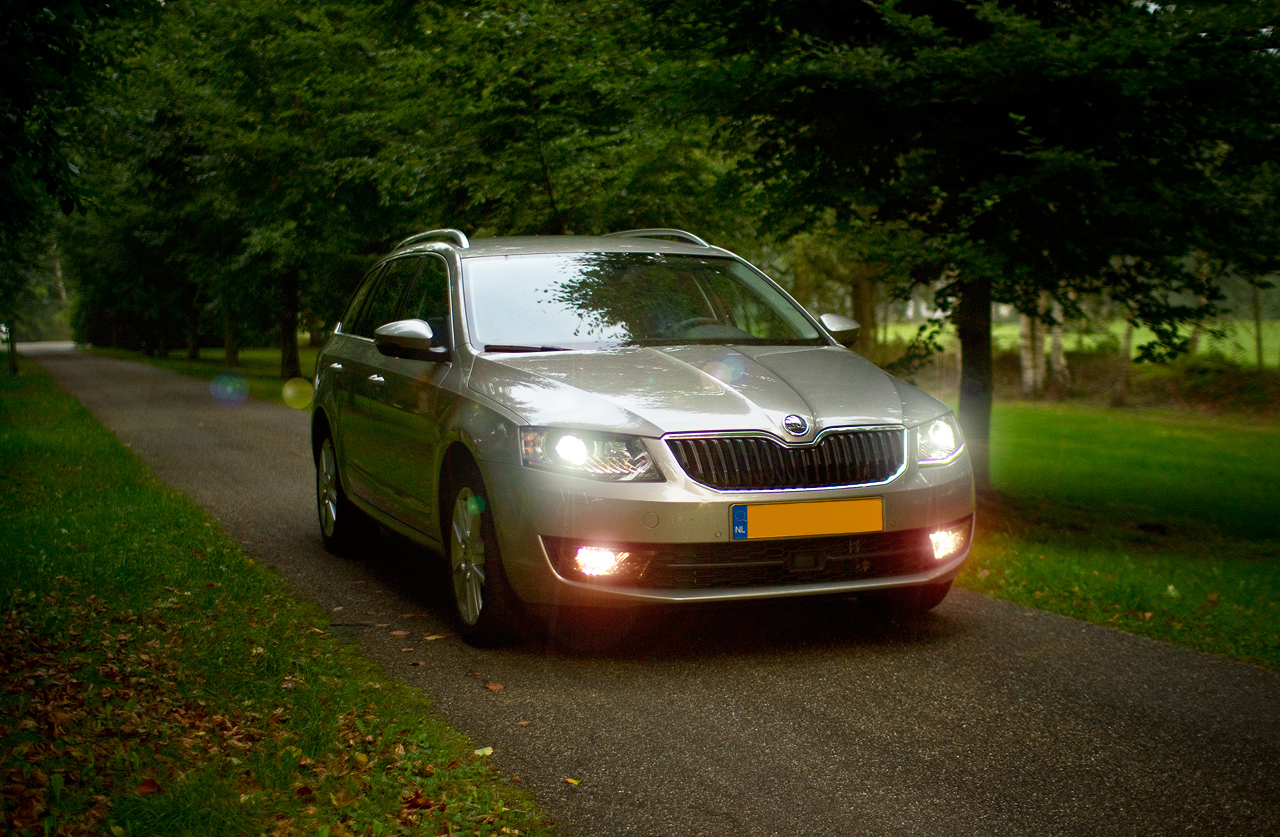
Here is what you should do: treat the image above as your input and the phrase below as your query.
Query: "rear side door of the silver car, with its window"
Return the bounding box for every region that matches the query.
[340,256,422,517]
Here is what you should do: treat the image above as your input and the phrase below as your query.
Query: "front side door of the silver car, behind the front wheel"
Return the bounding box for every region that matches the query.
[371,253,457,536]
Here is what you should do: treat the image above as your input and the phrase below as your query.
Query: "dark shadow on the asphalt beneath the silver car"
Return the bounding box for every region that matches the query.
[345,530,968,660]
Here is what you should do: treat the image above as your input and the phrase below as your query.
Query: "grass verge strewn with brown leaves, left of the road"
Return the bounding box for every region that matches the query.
[0,363,548,837]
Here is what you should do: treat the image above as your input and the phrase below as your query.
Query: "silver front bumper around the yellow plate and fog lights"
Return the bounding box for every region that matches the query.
[483,445,974,607]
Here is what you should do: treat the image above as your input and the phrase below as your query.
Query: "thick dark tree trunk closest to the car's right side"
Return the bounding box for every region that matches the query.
[956,276,995,493]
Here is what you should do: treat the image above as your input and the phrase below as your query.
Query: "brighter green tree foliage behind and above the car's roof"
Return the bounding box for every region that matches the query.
[55,0,748,371]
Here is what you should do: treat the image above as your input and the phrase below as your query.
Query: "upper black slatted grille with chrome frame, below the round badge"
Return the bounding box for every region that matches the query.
[667,427,906,491]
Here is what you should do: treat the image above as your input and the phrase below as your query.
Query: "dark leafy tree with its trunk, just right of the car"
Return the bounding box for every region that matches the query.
[654,0,1280,488]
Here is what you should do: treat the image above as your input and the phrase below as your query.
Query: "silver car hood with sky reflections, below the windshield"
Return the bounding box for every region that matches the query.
[468,346,946,442]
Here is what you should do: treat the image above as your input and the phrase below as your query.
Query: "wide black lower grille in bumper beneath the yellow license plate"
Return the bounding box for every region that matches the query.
[543,529,952,590]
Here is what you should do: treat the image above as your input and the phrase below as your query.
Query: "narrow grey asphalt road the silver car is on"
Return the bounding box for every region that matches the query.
[28,347,1280,837]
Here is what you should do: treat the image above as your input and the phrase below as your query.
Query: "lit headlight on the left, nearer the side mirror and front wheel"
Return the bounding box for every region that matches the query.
[520,427,662,482]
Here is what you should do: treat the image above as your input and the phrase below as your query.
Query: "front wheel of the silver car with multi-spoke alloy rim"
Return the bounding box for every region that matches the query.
[447,466,520,648]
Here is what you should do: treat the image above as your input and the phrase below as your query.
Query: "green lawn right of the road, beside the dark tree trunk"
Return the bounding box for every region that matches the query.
[959,403,1280,671]
